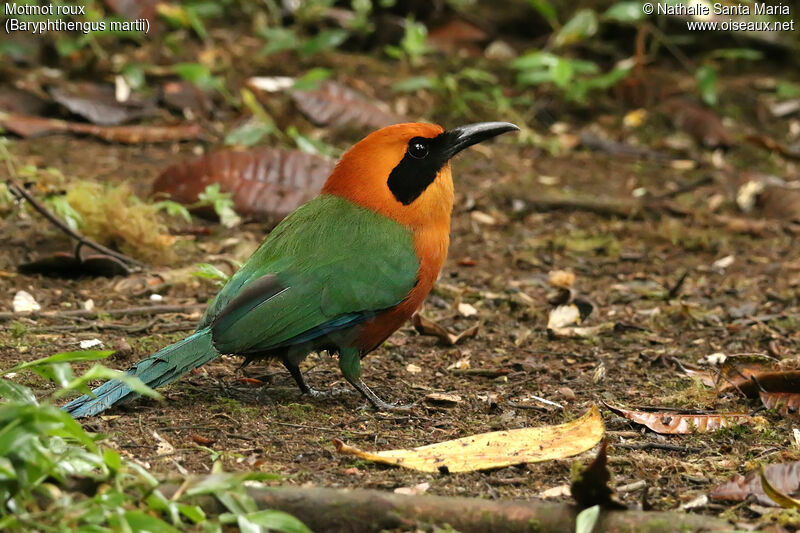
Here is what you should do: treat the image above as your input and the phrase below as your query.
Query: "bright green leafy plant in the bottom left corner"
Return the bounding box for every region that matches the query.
[0,351,309,533]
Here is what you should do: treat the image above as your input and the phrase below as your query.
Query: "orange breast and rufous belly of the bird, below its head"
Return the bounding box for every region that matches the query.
[354,218,450,356]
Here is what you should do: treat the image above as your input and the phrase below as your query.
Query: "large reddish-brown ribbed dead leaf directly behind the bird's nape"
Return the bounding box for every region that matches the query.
[153,148,335,222]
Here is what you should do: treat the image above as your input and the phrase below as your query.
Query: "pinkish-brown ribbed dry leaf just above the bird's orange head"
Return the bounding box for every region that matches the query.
[289,81,407,129]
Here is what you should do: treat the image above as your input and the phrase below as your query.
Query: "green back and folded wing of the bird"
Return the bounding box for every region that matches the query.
[200,194,419,354]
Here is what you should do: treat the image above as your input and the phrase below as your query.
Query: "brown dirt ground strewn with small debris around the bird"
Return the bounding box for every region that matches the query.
[0,55,800,520]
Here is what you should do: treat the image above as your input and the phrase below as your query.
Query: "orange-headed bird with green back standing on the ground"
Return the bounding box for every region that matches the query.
[62,122,519,418]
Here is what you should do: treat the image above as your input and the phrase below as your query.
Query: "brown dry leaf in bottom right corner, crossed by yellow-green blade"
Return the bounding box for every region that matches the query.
[709,461,800,507]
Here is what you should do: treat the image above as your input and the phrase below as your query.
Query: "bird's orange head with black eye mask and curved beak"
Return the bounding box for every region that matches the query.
[322,122,519,228]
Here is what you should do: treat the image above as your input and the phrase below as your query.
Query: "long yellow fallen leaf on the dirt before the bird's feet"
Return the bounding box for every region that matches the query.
[333,406,605,473]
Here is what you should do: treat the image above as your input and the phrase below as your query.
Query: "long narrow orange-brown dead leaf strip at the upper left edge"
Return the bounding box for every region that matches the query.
[0,112,203,144]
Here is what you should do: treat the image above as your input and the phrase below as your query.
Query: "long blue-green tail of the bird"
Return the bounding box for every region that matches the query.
[62,328,220,418]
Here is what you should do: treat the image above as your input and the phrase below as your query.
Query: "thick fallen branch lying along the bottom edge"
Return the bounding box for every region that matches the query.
[160,485,731,533]
